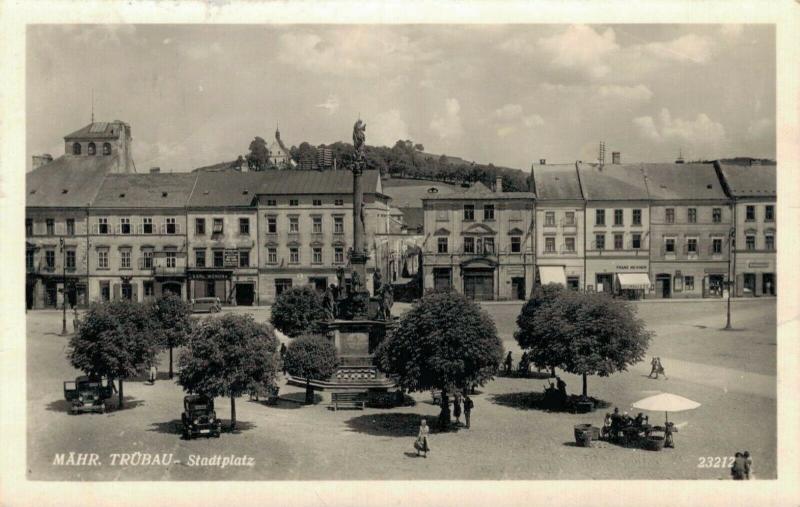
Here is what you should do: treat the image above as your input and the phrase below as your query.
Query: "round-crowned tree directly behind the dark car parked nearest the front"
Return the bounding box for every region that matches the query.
[178,314,278,430]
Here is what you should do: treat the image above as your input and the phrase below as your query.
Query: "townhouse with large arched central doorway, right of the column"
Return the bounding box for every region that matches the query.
[422,179,535,300]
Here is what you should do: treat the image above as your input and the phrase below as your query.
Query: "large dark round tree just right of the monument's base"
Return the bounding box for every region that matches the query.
[375,291,503,427]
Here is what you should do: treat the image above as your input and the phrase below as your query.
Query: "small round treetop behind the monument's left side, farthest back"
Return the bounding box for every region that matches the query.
[270,286,325,337]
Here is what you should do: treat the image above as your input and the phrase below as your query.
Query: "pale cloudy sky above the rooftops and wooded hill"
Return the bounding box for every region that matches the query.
[27,25,775,171]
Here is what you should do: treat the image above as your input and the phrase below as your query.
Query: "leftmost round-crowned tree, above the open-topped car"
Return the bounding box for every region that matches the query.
[68,300,158,409]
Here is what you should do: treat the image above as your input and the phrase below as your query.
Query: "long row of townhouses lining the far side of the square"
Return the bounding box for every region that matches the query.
[25,122,777,308]
